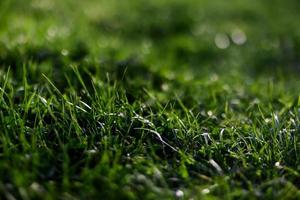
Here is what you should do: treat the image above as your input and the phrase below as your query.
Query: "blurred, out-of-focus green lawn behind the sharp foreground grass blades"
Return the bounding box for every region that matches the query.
[0,0,300,84]
